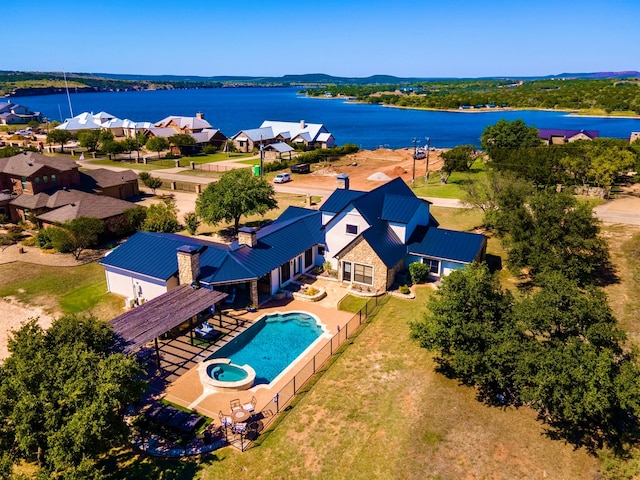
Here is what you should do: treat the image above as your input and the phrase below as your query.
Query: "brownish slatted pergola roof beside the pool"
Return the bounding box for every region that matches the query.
[109,285,227,353]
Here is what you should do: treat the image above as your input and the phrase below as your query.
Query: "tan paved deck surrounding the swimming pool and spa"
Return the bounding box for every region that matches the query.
[161,299,353,419]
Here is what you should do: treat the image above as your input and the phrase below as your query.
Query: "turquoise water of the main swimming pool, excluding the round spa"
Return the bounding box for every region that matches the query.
[208,312,322,385]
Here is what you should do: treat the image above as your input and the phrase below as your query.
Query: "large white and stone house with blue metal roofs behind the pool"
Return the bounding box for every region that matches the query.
[100,178,486,305]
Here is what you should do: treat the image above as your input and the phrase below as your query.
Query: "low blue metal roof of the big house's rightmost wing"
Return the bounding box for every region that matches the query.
[408,228,486,263]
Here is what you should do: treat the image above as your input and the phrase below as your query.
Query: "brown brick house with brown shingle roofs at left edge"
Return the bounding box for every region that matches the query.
[0,152,139,222]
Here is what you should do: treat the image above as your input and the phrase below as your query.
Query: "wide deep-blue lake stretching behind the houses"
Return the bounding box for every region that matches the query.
[11,87,640,149]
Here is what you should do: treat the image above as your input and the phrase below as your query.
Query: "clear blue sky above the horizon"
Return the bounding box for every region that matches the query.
[0,0,640,77]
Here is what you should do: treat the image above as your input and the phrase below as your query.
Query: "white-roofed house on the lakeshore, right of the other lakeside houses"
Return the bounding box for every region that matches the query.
[231,120,335,152]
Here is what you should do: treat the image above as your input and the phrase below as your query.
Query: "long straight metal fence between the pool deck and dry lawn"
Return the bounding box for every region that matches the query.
[240,295,389,451]
